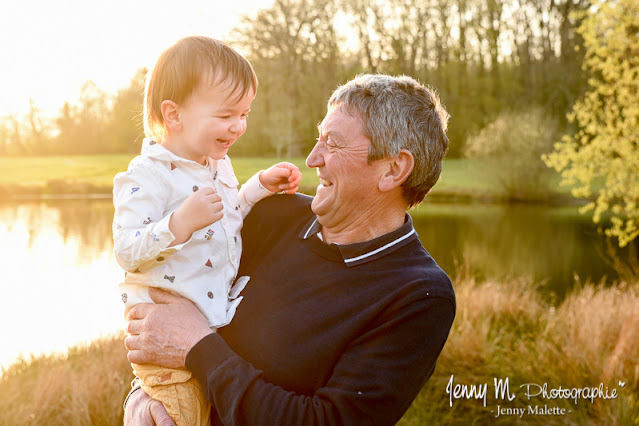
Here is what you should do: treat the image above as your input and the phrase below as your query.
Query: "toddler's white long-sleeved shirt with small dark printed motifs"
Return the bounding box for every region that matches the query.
[113,139,272,327]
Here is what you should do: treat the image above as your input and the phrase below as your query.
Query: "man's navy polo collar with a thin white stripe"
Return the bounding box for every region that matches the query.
[299,213,418,266]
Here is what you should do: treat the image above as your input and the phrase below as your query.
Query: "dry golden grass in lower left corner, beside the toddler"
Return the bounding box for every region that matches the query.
[0,335,132,425]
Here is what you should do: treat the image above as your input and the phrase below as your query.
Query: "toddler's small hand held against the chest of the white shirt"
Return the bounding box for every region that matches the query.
[169,188,224,245]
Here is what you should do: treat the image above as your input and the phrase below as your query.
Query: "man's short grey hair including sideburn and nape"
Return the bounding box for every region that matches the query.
[328,74,450,207]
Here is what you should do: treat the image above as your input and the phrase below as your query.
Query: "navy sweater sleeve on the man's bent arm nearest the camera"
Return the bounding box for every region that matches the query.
[186,297,455,425]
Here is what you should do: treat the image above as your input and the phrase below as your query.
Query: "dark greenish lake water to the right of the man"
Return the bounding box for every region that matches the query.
[411,204,617,299]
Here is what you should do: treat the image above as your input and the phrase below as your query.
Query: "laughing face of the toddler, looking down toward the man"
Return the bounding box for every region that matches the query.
[174,79,255,164]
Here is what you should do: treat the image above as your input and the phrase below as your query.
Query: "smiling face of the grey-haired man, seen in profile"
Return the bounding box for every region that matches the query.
[306,108,382,229]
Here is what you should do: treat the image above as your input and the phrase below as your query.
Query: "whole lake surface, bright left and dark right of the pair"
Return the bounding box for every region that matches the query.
[0,199,632,366]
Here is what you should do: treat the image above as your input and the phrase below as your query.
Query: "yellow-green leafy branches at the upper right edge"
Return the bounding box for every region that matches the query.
[544,0,639,247]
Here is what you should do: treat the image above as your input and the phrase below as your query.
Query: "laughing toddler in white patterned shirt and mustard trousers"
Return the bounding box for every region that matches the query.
[113,37,301,425]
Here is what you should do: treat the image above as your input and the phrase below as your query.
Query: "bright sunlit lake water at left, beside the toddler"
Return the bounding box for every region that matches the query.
[0,200,123,366]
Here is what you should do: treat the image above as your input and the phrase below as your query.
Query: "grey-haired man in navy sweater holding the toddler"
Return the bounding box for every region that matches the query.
[125,75,455,425]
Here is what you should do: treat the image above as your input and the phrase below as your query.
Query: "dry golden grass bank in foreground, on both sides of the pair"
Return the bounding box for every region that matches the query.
[0,274,639,425]
